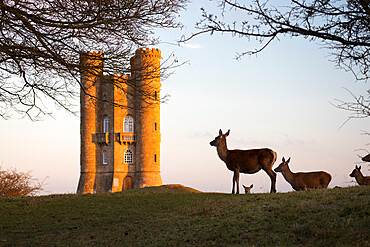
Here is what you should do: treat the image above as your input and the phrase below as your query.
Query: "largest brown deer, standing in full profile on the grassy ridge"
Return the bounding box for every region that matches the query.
[209,130,277,194]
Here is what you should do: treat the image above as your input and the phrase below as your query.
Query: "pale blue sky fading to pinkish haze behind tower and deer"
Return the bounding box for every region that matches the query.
[0,1,370,194]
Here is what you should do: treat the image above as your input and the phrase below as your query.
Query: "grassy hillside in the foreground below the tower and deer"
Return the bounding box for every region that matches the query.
[0,186,370,246]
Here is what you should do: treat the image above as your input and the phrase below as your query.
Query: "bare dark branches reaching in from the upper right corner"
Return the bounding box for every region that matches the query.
[180,0,370,81]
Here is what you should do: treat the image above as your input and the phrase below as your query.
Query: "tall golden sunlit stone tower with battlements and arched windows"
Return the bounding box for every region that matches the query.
[77,48,162,193]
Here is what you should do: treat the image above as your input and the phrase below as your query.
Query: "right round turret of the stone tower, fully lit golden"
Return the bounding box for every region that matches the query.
[131,48,162,188]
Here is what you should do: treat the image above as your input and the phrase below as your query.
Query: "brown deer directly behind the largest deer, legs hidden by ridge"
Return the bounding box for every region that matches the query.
[274,157,331,190]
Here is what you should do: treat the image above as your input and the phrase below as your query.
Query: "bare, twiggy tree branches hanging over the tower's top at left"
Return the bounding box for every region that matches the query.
[0,0,186,119]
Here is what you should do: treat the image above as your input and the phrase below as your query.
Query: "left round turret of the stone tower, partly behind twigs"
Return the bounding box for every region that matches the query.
[77,52,103,193]
